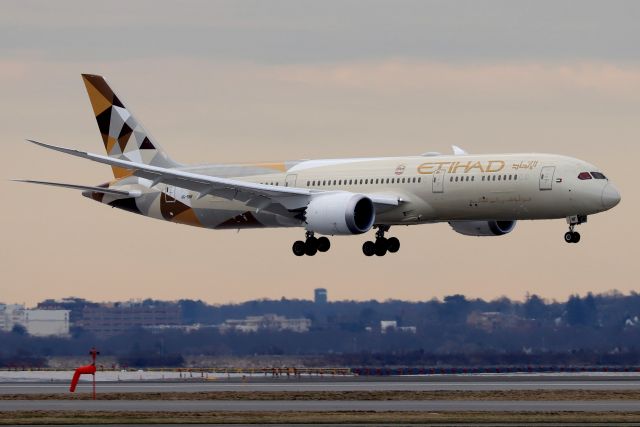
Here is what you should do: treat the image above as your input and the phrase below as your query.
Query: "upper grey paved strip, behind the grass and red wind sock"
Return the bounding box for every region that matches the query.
[0,375,640,395]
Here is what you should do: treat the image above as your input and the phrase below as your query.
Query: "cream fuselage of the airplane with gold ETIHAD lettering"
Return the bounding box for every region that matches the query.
[112,154,620,228]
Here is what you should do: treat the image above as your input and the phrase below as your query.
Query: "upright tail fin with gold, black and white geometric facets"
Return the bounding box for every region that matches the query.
[82,74,179,178]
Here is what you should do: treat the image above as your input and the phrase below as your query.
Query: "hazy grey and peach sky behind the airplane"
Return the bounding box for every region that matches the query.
[0,0,640,305]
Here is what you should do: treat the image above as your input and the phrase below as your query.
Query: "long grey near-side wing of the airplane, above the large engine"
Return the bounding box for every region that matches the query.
[27,140,401,210]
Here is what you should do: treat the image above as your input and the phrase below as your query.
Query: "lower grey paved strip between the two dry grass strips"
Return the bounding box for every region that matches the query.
[0,400,640,412]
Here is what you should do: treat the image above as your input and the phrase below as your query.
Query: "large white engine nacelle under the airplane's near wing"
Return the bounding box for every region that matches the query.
[305,192,376,236]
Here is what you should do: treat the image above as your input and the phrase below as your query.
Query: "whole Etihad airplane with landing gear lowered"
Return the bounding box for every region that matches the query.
[16,74,621,256]
